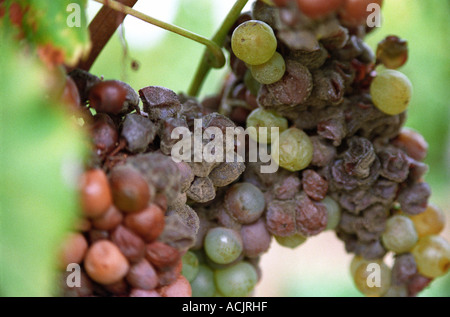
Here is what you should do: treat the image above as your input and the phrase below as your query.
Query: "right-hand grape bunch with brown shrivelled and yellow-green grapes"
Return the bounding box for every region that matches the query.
[207,1,450,296]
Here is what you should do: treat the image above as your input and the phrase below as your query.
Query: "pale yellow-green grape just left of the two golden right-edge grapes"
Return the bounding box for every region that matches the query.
[381,215,418,253]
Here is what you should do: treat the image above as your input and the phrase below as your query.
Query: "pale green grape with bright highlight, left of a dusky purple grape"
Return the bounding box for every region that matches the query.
[204,227,243,264]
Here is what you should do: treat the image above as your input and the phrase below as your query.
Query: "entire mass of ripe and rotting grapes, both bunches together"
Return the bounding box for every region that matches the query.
[55,0,450,297]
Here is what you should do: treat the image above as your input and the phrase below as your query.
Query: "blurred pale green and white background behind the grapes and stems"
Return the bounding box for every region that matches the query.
[89,0,450,296]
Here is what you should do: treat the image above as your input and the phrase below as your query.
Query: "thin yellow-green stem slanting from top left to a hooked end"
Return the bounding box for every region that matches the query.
[94,0,225,68]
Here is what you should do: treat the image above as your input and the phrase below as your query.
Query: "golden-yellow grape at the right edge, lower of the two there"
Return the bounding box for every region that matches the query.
[411,235,450,278]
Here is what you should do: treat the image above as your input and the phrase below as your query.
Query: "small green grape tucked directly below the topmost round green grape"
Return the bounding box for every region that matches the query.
[249,52,286,85]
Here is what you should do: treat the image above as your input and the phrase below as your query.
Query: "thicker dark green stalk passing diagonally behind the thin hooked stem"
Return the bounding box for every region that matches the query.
[188,0,248,96]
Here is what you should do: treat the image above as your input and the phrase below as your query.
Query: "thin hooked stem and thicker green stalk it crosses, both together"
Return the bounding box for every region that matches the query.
[94,0,248,96]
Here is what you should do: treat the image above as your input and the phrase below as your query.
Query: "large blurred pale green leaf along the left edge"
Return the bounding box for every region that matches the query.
[0,31,84,296]
